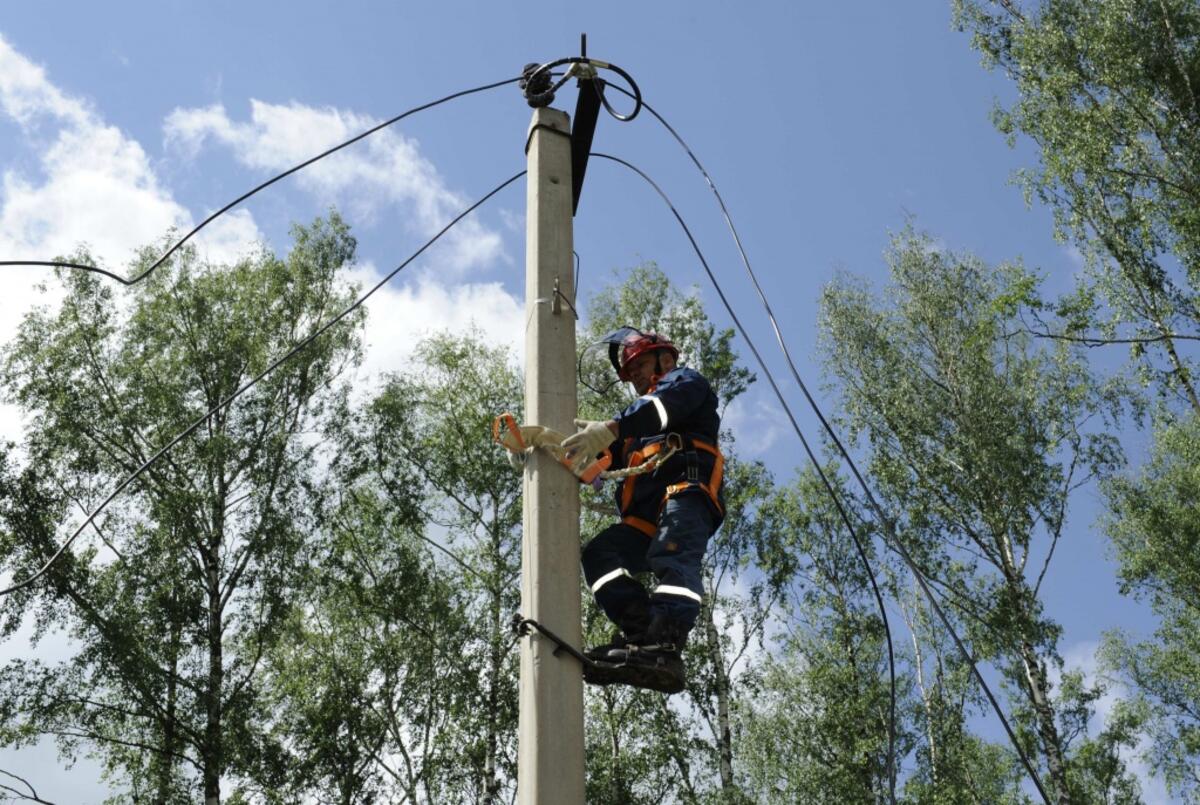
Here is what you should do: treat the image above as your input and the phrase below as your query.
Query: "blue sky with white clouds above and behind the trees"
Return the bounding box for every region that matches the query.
[0,0,1170,803]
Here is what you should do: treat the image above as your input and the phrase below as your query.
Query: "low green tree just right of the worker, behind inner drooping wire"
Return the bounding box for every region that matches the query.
[743,467,911,804]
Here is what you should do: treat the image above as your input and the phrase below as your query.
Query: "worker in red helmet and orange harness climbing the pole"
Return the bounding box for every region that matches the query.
[563,328,725,693]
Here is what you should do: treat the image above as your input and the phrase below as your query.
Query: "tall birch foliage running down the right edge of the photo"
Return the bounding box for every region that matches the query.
[955,0,1200,797]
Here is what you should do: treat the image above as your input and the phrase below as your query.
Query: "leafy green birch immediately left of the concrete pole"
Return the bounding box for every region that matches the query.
[276,332,521,803]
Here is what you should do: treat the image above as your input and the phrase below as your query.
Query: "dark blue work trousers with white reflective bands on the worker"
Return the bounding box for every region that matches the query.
[583,494,716,632]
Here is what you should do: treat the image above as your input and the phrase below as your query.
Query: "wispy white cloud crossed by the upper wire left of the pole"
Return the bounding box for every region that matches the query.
[164,100,504,277]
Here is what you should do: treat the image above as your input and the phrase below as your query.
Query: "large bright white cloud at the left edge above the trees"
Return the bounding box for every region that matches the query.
[0,37,270,439]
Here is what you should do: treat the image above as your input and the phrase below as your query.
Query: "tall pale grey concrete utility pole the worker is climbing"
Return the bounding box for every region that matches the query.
[517,108,583,805]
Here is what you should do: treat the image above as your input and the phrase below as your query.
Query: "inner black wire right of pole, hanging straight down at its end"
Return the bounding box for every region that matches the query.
[592,151,896,801]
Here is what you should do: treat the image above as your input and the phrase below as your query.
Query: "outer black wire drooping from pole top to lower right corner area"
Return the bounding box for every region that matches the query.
[613,85,1050,805]
